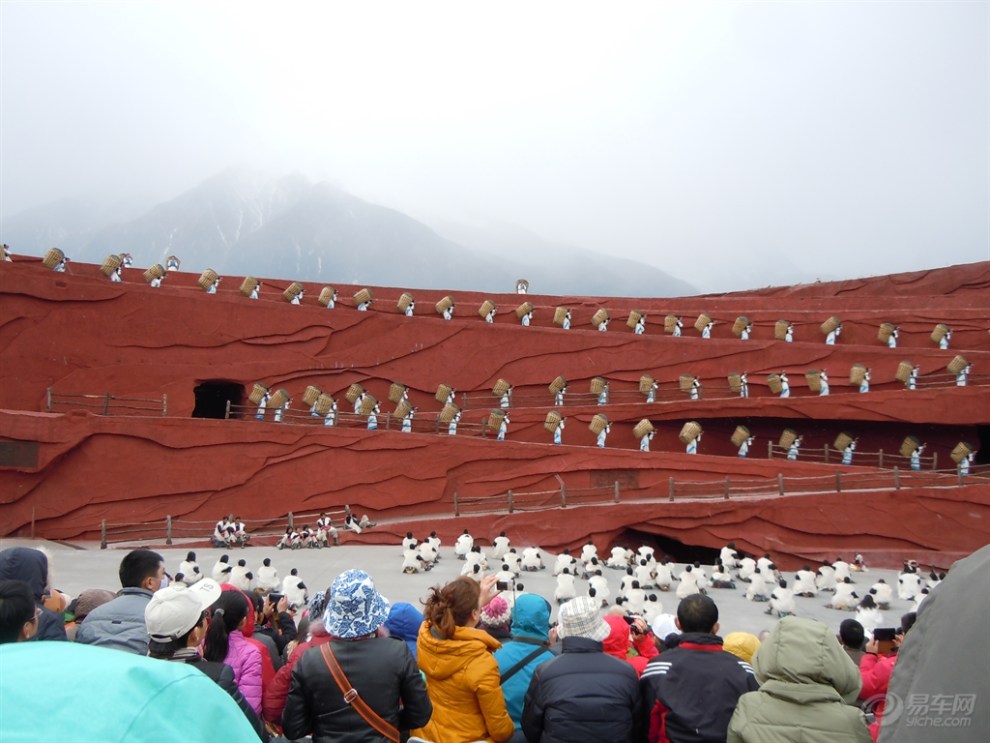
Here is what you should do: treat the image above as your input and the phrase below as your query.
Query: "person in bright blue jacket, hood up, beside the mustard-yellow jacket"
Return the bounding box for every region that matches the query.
[495,593,556,731]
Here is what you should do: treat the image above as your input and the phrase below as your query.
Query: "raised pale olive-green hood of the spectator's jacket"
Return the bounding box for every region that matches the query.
[753,617,863,702]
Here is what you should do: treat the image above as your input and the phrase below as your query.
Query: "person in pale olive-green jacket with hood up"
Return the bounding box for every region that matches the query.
[727,616,871,743]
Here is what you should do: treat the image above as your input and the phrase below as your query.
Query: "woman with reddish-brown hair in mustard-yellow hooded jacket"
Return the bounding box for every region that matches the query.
[415,575,515,743]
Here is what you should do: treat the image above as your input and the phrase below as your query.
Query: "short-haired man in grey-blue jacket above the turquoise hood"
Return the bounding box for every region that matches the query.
[76,550,168,655]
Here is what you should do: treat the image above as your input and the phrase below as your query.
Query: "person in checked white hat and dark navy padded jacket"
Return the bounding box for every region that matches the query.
[522,596,645,743]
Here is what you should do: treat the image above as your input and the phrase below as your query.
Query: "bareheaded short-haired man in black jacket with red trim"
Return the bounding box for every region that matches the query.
[640,593,759,743]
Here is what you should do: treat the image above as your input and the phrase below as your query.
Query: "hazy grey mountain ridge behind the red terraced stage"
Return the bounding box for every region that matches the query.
[0,168,696,297]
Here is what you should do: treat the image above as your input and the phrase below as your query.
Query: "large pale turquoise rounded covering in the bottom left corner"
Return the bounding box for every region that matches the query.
[0,642,258,743]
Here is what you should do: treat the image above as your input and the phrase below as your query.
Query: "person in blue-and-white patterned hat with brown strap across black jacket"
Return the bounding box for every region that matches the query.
[282,570,432,743]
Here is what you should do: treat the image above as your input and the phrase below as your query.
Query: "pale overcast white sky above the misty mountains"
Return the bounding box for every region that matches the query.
[0,0,990,291]
